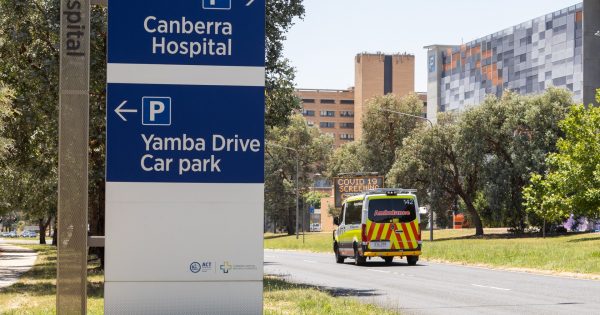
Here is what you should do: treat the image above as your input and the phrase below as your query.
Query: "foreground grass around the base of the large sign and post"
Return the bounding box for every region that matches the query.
[0,245,396,315]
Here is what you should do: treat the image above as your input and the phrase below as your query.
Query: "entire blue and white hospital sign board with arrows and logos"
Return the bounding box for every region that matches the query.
[105,0,265,314]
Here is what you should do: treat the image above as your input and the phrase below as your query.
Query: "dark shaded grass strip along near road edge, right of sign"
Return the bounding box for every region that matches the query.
[263,276,381,297]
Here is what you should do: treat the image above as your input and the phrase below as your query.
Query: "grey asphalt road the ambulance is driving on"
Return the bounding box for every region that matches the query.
[265,250,600,314]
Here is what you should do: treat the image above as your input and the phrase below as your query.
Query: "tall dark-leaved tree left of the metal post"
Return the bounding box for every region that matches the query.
[0,0,60,243]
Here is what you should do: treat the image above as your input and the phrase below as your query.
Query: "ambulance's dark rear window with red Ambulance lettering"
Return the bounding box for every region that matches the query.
[369,198,417,223]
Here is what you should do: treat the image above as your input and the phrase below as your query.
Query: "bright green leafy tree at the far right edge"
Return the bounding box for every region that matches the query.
[524,99,600,220]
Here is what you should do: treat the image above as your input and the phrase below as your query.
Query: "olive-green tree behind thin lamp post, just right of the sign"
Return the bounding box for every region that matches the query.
[265,114,333,234]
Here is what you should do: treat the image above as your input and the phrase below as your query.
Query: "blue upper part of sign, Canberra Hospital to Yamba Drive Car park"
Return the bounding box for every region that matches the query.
[106,0,265,183]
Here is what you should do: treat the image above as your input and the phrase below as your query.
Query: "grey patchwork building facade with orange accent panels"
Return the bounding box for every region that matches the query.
[425,0,600,120]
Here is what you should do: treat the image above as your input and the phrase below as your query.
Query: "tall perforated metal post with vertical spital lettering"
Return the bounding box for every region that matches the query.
[56,0,90,315]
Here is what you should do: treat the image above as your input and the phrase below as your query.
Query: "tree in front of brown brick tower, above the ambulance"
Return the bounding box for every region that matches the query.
[362,94,423,174]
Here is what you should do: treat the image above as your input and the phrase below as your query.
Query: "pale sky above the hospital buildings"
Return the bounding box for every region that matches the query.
[284,0,581,92]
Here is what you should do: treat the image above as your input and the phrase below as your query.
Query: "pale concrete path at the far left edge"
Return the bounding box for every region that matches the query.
[0,239,37,289]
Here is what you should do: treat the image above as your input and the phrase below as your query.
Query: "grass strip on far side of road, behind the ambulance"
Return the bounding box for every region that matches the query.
[264,229,600,276]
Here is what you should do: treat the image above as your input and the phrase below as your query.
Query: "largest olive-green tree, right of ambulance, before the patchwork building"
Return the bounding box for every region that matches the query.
[387,89,572,234]
